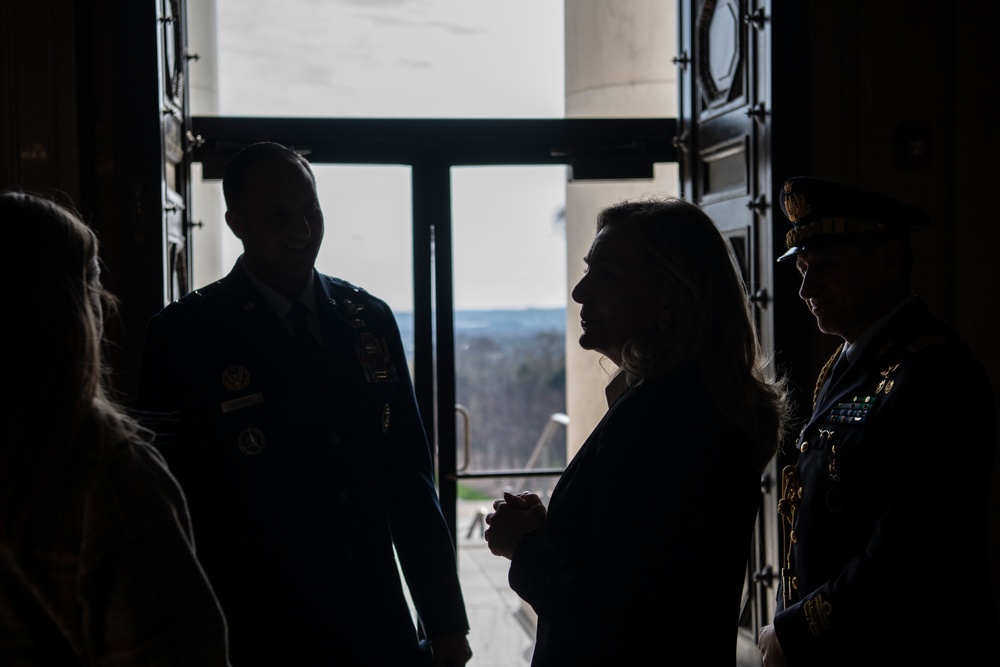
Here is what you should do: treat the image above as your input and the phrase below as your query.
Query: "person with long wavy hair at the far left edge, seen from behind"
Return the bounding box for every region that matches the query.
[0,192,229,667]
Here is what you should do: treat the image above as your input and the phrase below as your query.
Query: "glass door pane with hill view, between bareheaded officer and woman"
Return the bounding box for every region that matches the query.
[451,165,568,667]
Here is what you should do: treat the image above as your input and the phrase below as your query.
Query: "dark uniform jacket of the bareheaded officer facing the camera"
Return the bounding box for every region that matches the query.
[138,262,468,667]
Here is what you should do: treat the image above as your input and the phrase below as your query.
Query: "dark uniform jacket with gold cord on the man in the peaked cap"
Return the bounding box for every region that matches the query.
[774,297,1000,665]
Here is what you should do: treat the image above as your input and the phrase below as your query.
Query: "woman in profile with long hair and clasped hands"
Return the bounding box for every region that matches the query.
[486,198,788,667]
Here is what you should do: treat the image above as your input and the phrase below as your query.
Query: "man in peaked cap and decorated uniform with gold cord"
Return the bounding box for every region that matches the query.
[759,177,1000,667]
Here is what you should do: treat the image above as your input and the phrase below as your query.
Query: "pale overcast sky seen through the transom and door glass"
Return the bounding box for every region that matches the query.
[209,0,566,310]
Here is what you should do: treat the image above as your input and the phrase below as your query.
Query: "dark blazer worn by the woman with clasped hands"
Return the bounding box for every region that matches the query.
[509,370,760,667]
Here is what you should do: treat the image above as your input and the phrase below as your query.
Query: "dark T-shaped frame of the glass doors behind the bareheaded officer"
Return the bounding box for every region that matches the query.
[187,116,677,545]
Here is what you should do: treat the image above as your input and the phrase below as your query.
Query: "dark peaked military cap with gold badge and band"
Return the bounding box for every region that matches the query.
[778,176,930,262]
